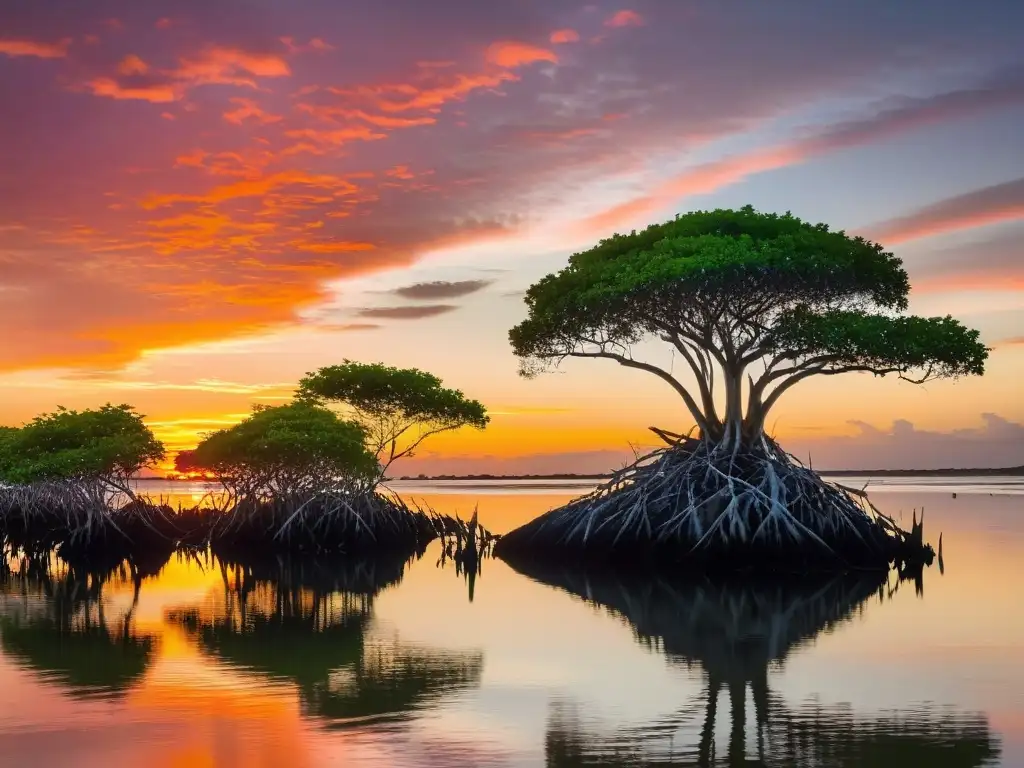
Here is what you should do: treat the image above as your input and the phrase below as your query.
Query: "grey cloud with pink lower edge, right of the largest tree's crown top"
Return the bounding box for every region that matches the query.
[870,178,1024,243]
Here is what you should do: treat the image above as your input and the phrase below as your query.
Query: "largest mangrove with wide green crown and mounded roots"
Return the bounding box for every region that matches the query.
[495,207,988,572]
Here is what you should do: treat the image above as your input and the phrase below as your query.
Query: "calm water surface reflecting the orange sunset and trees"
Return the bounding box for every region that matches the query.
[0,478,1024,768]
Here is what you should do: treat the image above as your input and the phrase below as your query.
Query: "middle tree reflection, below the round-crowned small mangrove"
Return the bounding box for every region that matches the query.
[170,556,483,727]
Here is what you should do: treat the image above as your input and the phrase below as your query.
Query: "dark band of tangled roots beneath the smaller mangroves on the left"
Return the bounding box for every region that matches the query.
[0,482,456,563]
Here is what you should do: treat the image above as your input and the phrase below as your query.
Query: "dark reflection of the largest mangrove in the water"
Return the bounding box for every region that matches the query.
[507,563,999,768]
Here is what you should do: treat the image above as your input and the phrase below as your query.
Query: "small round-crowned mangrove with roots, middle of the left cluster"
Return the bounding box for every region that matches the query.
[186,400,435,553]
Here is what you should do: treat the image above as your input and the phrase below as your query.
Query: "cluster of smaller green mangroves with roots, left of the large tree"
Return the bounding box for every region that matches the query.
[0,360,492,565]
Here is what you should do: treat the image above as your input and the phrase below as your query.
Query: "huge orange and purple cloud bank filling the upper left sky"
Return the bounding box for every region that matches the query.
[0,0,1024,369]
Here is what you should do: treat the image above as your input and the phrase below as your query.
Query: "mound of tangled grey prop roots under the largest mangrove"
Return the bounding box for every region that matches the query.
[495,441,931,571]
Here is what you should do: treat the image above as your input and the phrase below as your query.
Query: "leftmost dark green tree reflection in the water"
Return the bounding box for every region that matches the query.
[0,554,164,697]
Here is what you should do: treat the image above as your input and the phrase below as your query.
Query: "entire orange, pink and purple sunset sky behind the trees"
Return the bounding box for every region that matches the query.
[0,0,1024,473]
